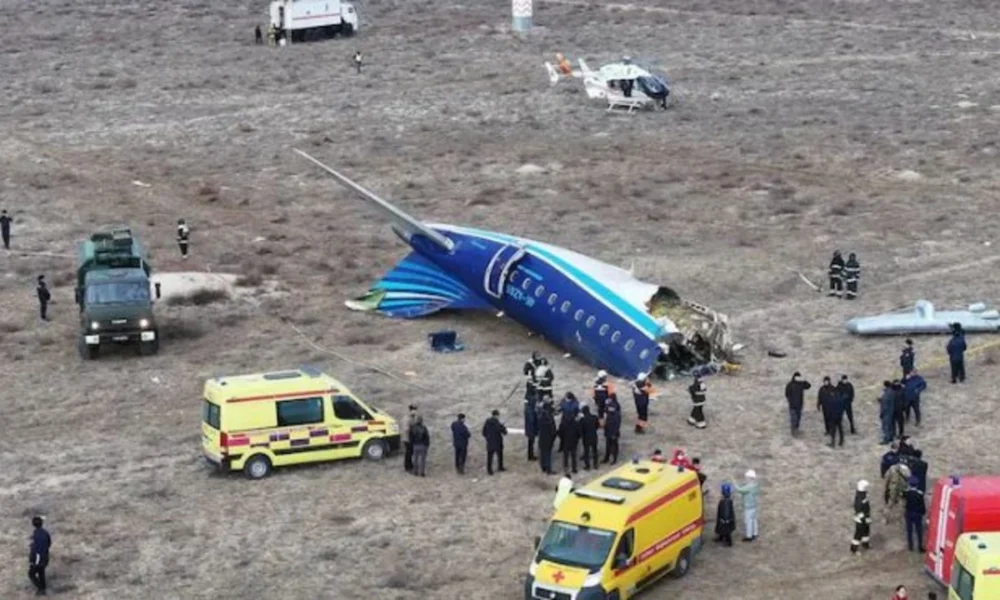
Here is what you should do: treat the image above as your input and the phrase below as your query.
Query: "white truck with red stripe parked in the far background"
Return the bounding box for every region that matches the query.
[271,0,358,43]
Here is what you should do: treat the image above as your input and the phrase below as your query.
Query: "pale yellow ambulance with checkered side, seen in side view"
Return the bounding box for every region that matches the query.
[201,367,399,479]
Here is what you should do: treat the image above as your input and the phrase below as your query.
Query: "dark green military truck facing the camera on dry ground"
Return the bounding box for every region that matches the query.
[76,226,160,359]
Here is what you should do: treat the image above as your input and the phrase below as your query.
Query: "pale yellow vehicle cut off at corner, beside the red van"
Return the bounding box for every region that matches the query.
[948,532,1000,600]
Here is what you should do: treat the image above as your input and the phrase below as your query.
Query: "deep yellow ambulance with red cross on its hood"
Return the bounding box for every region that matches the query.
[524,461,705,600]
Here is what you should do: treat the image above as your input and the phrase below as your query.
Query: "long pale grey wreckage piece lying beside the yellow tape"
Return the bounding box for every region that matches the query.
[845,300,1000,335]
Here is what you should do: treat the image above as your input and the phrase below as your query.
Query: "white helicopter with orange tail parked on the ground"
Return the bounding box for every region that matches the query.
[545,54,670,112]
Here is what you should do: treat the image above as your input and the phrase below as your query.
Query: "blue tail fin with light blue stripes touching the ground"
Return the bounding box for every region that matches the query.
[345,252,494,319]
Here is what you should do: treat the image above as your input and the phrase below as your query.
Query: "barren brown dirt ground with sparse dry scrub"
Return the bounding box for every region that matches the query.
[0,0,1000,600]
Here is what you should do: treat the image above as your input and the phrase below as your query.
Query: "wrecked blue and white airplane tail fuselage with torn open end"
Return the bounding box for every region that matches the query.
[292,152,733,378]
